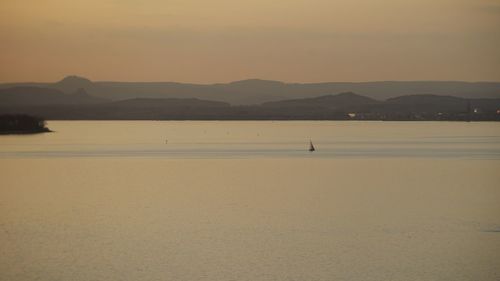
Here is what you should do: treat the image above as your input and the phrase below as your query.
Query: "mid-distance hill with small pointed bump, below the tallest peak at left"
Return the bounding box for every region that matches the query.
[0,87,106,107]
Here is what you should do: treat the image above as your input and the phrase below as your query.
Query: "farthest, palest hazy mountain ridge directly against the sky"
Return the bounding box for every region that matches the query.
[0,76,500,105]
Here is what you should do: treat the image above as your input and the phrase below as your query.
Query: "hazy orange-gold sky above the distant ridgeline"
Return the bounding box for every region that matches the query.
[0,0,500,83]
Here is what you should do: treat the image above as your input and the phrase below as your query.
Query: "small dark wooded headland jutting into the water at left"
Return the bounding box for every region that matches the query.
[0,114,50,135]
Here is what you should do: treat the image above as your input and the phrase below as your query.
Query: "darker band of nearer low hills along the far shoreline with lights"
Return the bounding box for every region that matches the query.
[0,88,500,121]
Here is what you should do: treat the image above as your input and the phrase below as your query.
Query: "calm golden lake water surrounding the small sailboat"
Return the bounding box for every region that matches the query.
[0,121,500,281]
